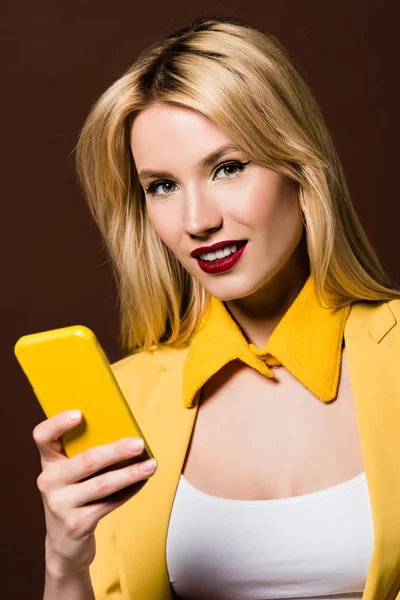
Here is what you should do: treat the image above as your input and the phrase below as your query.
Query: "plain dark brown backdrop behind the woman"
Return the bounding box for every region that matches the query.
[0,0,400,600]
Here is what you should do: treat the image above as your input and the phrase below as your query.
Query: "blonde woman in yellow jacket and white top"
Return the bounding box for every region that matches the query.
[34,12,400,600]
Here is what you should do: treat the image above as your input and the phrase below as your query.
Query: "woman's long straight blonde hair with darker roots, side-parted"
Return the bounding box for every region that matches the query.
[76,17,400,352]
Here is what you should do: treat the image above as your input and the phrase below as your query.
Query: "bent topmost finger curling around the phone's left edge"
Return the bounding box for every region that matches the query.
[32,410,82,461]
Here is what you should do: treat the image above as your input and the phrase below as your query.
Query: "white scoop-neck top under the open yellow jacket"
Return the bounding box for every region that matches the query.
[167,473,374,600]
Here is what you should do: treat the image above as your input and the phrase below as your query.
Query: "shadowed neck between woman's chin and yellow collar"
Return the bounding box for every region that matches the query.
[225,234,310,348]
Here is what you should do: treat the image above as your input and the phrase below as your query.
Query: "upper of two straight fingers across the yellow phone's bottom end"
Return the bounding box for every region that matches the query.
[62,437,147,484]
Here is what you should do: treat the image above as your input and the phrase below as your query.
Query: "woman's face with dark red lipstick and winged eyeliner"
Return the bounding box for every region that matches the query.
[131,103,303,300]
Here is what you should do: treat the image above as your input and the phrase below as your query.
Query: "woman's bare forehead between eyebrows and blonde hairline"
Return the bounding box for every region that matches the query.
[130,103,233,169]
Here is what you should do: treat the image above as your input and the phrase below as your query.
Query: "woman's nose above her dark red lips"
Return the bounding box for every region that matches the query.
[184,188,223,237]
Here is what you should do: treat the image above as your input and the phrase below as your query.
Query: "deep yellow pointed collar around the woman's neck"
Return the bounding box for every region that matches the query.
[183,274,351,408]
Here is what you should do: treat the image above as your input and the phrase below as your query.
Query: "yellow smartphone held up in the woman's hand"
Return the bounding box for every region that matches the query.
[14,325,154,466]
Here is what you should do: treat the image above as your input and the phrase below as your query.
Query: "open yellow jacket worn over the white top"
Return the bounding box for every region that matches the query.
[91,300,400,600]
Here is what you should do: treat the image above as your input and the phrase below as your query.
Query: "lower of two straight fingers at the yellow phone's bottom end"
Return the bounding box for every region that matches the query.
[69,459,156,506]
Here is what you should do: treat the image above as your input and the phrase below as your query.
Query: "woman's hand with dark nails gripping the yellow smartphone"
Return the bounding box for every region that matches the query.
[33,411,156,575]
